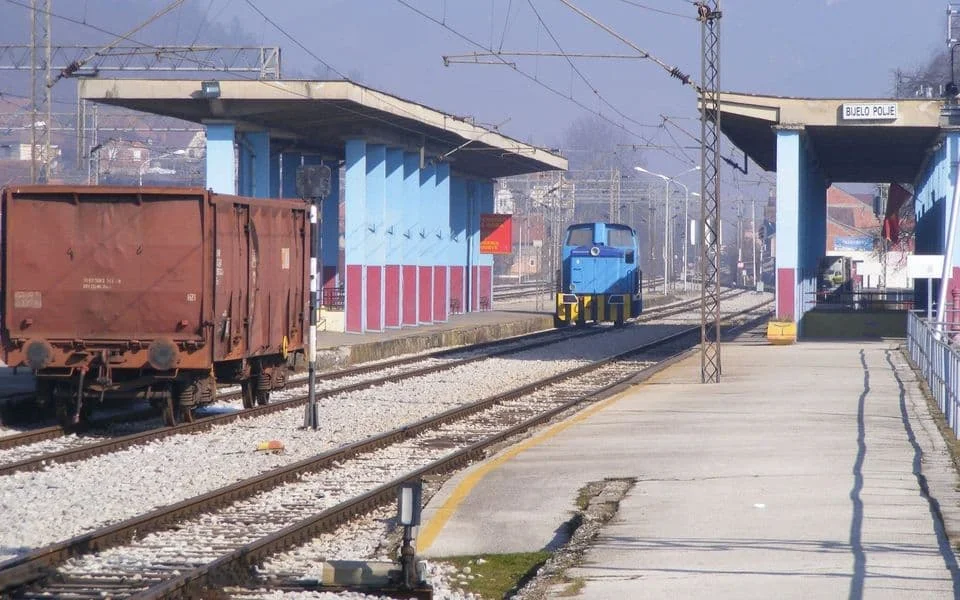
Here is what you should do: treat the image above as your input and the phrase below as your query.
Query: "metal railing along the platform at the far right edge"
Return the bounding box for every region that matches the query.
[907,312,960,437]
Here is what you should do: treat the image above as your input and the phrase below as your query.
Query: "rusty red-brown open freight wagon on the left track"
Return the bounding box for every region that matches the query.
[0,185,310,423]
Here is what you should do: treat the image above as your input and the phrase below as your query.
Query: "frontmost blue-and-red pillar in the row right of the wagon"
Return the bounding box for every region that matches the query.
[343,139,367,333]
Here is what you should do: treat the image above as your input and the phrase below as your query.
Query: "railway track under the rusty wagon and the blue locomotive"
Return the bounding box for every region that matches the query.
[0,290,744,466]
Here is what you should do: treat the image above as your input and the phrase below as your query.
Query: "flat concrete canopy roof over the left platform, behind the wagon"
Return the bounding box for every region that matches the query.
[79,79,567,178]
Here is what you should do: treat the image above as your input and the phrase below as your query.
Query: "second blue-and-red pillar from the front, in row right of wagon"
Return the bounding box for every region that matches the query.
[364,144,387,331]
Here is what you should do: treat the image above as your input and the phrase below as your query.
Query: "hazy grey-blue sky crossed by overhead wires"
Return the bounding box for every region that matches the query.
[0,0,946,203]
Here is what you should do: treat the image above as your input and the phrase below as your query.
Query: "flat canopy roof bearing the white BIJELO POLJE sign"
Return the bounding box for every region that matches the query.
[708,92,942,183]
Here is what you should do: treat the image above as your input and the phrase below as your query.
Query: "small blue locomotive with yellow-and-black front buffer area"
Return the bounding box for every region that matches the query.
[554,223,643,327]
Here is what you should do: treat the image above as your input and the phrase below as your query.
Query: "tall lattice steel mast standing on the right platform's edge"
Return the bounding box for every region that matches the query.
[696,0,722,383]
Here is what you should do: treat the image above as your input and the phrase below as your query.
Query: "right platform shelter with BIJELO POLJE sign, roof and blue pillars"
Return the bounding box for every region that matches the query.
[708,93,948,335]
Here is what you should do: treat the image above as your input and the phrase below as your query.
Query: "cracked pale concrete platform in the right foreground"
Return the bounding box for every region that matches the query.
[419,336,960,600]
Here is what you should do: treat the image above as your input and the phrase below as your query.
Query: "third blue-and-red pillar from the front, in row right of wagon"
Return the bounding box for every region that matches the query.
[383,148,404,327]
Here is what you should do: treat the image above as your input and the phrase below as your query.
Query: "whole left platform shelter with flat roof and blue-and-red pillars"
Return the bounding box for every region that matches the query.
[79,79,567,333]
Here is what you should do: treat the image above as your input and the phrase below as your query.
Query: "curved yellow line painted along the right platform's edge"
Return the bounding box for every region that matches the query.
[417,373,660,552]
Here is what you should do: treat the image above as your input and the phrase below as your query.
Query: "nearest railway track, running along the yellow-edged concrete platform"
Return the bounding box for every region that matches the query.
[0,301,771,598]
